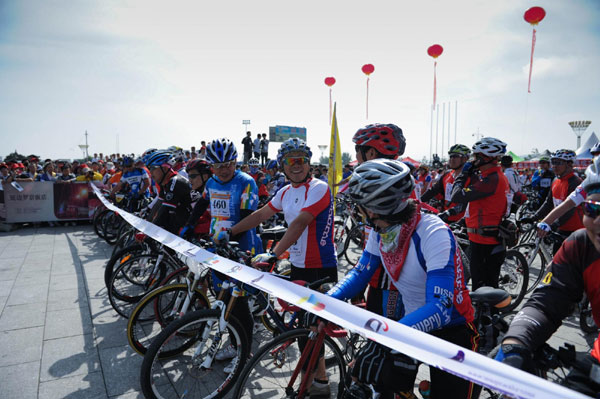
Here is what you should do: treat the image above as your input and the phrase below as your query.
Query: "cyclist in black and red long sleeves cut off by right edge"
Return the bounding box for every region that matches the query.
[496,159,600,397]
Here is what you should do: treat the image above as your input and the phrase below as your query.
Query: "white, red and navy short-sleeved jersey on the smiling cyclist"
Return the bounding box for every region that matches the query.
[269,179,337,269]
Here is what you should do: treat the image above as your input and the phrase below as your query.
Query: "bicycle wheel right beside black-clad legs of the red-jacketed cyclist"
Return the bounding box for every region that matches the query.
[498,249,529,312]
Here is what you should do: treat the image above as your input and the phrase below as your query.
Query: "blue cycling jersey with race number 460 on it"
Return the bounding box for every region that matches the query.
[202,170,262,253]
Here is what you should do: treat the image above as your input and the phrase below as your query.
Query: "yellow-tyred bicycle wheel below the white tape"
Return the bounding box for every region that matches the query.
[127,284,209,355]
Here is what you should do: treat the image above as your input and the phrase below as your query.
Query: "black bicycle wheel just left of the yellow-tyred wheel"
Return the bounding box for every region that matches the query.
[108,255,168,318]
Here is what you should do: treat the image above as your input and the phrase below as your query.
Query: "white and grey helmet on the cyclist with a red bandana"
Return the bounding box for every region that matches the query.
[348,158,415,215]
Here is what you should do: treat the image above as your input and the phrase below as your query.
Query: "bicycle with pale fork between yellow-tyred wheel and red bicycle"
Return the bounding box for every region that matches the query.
[140,247,324,398]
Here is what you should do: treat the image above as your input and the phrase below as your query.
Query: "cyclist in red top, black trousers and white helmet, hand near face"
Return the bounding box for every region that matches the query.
[450,137,509,290]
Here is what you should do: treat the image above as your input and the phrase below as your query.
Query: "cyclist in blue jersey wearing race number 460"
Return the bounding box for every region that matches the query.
[202,138,262,372]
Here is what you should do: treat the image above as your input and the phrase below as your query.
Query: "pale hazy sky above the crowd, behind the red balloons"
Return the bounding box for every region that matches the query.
[0,0,600,160]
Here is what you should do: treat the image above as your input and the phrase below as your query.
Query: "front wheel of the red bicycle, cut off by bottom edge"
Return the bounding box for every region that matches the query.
[233,329,346,398]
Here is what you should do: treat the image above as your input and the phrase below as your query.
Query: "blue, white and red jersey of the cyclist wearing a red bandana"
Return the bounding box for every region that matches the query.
[328,213,473,332]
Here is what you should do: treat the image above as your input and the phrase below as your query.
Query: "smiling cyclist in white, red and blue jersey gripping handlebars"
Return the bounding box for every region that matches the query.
[216,138,337,398]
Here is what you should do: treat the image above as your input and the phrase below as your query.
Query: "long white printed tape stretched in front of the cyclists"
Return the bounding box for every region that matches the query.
[93,187,587,399]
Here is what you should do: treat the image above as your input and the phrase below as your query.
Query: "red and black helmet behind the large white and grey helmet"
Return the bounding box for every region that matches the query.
[352,123,406,157]
